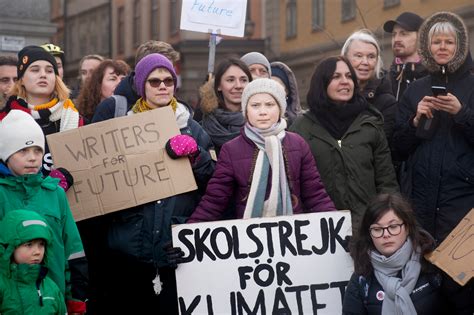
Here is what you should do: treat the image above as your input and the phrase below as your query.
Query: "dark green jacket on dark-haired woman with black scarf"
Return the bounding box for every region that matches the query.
[290,106,399,233]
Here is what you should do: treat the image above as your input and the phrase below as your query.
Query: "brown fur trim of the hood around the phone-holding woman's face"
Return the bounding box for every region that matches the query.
[418,12,469,73]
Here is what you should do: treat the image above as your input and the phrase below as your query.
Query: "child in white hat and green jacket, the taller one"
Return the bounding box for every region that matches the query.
[0,110,88,314]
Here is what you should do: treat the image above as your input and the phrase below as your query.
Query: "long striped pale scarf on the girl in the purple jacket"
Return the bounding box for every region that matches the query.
[244,119,293,219]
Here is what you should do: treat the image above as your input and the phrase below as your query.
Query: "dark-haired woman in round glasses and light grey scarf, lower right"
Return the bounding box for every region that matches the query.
[342,194,446,315]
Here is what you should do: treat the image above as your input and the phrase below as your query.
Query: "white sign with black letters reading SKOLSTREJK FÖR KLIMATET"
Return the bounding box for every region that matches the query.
[172,211,353,315]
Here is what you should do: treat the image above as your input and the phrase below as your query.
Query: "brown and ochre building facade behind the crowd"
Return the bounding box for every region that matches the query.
[48,0,474,105]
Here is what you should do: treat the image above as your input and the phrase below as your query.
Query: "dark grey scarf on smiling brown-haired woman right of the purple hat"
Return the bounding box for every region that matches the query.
[201,108,245,147]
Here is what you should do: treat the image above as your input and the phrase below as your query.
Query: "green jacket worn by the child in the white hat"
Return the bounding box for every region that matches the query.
[0,172,88,308]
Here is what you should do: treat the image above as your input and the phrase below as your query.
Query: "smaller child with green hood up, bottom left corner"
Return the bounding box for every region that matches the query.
[0,210,66,315]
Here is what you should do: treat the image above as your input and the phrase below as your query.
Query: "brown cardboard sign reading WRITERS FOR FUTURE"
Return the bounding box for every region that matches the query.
[47,106,196,221]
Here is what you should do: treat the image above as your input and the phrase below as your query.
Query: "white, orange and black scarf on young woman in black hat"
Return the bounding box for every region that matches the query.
[25,98,79,132]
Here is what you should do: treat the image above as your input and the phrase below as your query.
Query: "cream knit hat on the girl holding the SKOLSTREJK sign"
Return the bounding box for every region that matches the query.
[242,78,286,118]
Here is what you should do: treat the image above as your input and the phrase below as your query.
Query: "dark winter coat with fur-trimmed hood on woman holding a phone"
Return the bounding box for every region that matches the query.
[393,12,474,242]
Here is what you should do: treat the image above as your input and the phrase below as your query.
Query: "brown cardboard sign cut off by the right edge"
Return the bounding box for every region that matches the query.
[426,208,474,285]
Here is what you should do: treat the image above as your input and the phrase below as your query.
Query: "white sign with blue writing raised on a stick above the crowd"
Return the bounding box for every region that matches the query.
[180,0,247,37]
